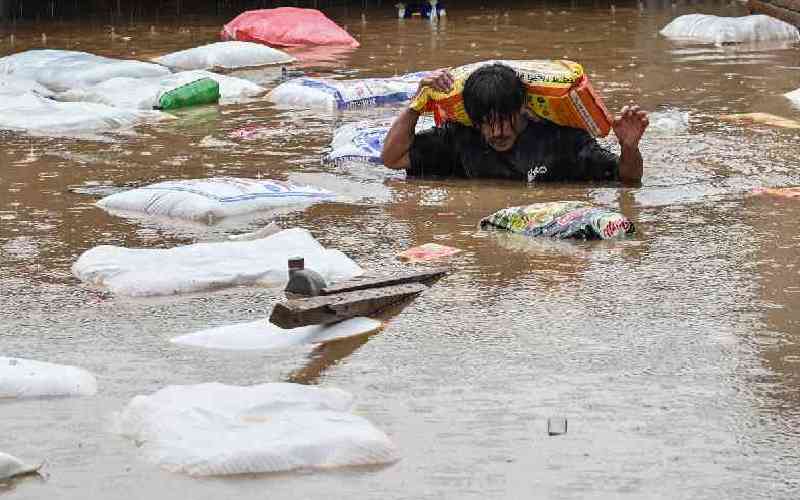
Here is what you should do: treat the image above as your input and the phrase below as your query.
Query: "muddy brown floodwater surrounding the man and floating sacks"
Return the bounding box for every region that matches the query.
[0,1,800,500]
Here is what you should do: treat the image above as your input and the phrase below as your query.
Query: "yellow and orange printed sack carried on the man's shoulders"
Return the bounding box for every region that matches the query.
[411,60,612,137]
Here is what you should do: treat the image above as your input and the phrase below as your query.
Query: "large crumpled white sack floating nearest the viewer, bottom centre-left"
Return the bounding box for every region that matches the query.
[114,383,398,476]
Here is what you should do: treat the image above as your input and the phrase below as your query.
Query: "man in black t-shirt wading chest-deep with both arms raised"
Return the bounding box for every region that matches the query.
[381,64,649,183]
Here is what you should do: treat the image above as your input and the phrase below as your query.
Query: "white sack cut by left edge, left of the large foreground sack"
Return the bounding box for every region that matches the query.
[0,356,97,399]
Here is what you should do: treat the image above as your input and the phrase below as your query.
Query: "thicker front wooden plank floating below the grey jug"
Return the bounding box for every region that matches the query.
[269,283,428,329]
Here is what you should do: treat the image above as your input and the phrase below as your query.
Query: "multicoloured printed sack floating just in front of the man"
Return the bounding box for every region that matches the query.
[481,201,634,240]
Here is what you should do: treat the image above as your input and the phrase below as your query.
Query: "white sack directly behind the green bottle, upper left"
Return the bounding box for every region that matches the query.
[55,71,266,109]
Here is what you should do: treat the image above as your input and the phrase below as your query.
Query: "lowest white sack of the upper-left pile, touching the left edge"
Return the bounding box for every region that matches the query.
[0,93,167,135]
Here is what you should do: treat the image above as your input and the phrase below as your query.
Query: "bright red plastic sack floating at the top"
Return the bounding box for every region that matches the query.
[222,7,359,47]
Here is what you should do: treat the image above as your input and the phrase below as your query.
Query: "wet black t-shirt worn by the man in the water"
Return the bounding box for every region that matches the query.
[406,119,619,182]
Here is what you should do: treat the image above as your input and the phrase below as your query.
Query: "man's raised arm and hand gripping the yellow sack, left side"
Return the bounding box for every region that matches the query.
[381,69,453,170]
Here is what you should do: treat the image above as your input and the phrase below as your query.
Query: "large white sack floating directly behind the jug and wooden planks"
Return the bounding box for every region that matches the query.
[72,228,363,297]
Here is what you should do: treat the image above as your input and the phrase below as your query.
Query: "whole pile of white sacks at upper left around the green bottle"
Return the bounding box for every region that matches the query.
[0,42,293,135]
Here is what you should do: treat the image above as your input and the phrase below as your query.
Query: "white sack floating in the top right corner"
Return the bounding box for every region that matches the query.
[660,14,800,44]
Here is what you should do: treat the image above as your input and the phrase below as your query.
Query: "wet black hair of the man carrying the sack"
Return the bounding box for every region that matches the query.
[463,63,525,126]
